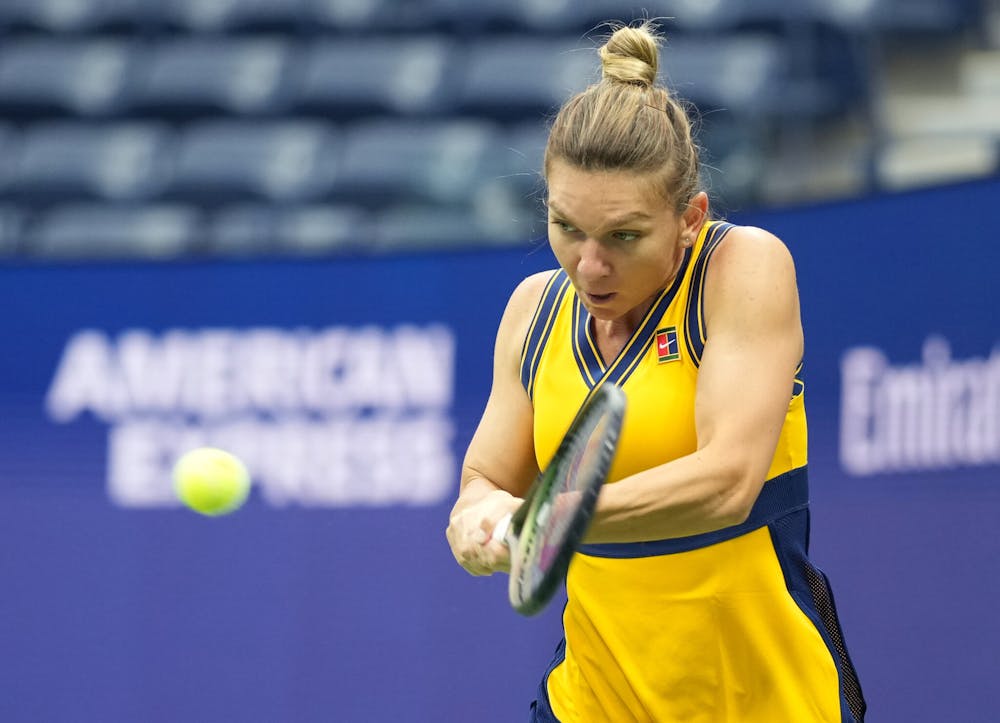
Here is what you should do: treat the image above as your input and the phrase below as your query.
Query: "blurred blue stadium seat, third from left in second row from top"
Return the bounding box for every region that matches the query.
[294,36,456,118]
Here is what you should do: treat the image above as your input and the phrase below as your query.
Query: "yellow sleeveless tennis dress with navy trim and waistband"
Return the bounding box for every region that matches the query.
[521,221,865,723]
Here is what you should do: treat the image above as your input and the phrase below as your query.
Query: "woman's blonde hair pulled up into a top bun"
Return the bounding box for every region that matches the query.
[544,21,700,212]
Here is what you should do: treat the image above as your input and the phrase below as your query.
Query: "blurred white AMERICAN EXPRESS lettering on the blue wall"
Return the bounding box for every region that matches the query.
[46,325,457,507]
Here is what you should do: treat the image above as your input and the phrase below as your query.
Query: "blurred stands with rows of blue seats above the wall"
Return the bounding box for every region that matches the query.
[0,0,1000,258]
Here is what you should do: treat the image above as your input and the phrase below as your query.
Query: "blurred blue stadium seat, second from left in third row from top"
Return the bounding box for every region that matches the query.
[169,120,339,203]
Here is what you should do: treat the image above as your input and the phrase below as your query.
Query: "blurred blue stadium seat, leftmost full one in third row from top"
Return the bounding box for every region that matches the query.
[7,121,170,204]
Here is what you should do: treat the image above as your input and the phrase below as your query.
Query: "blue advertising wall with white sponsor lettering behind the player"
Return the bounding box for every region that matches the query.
[0,182,1000,723]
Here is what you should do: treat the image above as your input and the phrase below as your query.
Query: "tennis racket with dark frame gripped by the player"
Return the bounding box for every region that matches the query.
[493,384,625,615]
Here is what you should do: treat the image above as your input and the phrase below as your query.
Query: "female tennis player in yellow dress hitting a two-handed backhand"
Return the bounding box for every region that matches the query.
[447,23,865,723]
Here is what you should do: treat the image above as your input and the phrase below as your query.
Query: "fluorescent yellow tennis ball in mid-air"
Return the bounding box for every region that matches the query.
[174,447,250,517]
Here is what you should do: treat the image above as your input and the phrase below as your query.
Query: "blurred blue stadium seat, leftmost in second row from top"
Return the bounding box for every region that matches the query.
[0,39,141,117]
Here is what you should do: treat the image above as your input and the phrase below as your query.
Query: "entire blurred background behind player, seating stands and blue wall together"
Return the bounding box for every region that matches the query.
[0,0,1000,723]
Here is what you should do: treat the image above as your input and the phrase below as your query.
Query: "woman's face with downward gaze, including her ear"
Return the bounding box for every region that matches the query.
[547,159,707,322]
